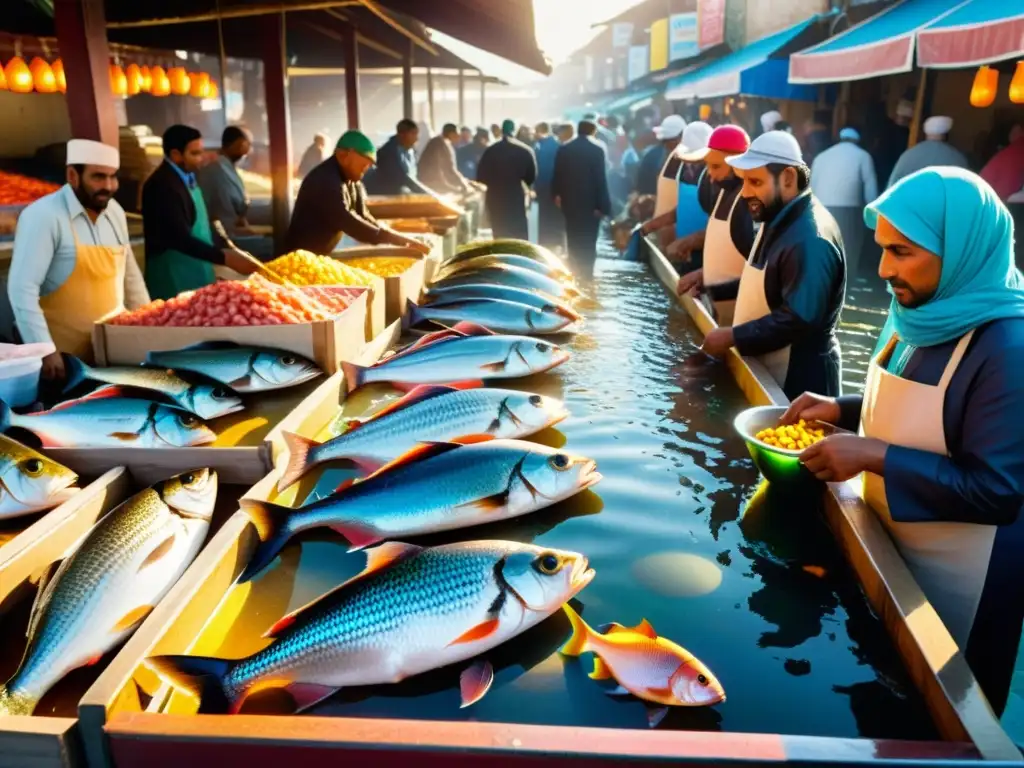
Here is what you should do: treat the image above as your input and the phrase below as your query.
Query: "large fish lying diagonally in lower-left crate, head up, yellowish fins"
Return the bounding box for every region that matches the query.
[0,469,217,715]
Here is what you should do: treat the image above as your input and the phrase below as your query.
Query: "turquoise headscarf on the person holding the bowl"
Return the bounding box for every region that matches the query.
[864,167,1024,364]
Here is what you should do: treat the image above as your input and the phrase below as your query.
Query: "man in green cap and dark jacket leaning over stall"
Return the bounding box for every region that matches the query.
[285,131,430,254]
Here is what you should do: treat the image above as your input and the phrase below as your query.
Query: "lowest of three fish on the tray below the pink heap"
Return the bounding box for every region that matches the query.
[0,391,217,447]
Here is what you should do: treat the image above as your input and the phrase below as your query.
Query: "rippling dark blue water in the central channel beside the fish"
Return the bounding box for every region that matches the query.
[199,260,935,738]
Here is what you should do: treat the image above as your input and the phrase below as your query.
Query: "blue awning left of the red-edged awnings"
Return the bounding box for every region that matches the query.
[665,16,819,101]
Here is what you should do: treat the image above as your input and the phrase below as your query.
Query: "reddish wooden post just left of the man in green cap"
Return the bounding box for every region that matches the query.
[260,13,292,253]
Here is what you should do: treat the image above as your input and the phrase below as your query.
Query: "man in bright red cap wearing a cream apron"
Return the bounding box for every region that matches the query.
[677,125,754,326]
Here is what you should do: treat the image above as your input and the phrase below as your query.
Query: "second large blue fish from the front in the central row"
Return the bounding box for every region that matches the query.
[241,436,601,581]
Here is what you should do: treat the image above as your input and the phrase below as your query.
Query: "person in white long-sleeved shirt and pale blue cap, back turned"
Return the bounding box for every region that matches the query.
[811,126,879,274]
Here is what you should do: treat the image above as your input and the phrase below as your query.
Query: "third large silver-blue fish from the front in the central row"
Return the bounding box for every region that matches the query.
[278,385,568,490]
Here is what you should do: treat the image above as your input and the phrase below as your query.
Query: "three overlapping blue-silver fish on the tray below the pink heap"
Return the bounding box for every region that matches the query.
[0,342,323,447]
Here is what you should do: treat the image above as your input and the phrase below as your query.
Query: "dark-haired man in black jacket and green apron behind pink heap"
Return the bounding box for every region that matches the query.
[142,125,256,299]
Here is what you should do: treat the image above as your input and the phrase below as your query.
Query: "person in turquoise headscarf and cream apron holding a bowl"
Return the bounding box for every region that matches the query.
[784,167,1024,713]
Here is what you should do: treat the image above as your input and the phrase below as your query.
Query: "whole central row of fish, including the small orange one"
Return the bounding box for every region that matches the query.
[147,242,725,727]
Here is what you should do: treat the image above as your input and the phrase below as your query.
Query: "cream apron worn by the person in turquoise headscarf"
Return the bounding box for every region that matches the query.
[860,331,996,650]
